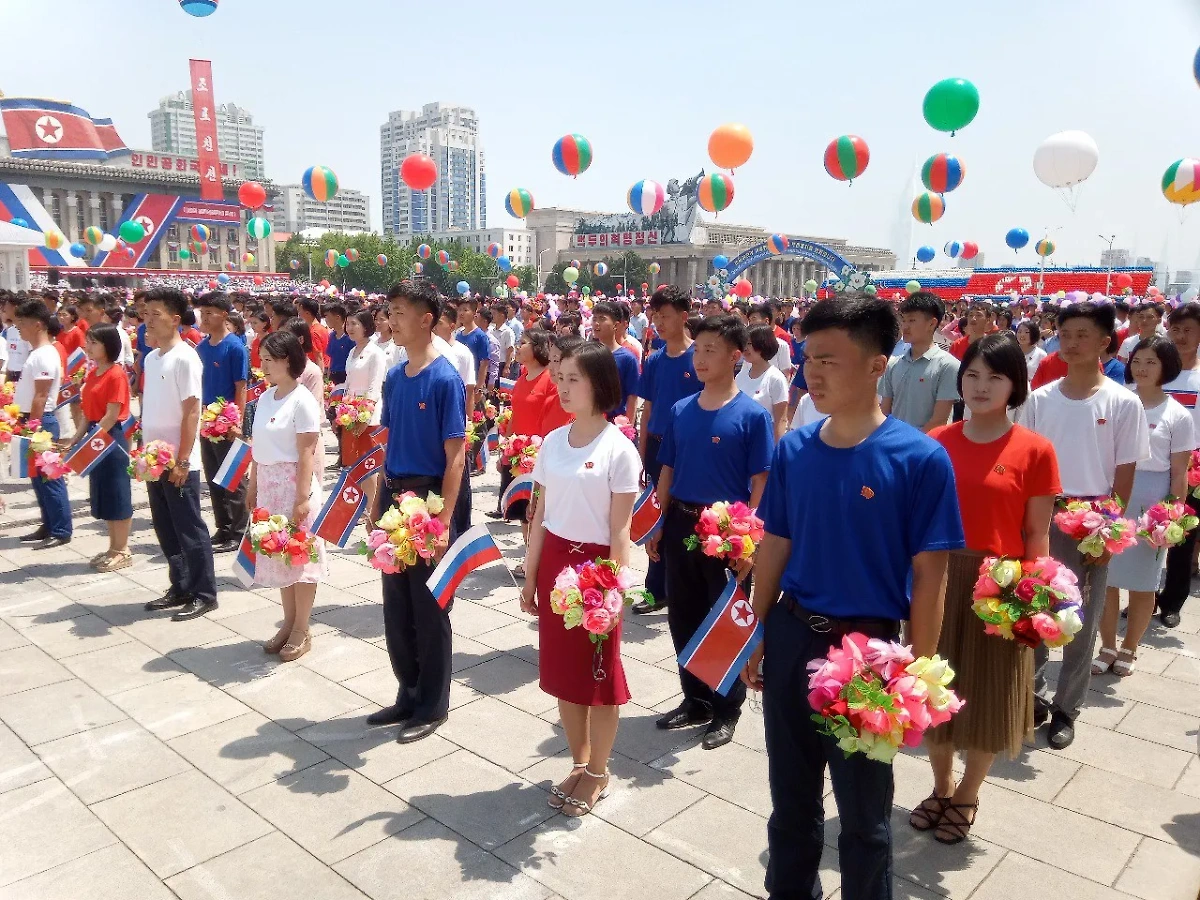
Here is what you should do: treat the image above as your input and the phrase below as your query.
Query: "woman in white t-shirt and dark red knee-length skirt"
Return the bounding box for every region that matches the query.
[521,343,642,816]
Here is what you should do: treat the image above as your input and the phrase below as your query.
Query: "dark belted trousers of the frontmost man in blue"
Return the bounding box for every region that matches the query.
[763,601,893,900]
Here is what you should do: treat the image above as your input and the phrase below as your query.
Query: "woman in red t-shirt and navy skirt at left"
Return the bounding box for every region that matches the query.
[79,323,133,572]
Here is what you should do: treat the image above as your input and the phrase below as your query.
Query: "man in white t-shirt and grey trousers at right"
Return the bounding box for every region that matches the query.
[1019,301,1150,750]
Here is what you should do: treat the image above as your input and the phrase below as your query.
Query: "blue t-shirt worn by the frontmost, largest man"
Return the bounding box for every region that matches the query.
[758,416,966,619]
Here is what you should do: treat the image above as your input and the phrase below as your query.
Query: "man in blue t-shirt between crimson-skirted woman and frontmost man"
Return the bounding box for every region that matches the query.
[647,316,774,750]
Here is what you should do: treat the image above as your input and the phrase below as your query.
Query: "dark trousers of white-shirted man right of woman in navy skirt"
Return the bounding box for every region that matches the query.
[146,472,217,602]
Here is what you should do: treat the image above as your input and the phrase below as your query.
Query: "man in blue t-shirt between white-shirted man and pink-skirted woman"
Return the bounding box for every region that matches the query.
[196,292,250,553]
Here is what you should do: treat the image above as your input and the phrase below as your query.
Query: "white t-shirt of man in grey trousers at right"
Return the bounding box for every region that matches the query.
[1018,378,1150,499]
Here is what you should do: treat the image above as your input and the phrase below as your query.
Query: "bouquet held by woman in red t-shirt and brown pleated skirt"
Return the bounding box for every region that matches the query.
[971,557,1084,647]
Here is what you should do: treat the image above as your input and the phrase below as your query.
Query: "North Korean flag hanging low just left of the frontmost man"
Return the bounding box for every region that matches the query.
[678,572,762,696]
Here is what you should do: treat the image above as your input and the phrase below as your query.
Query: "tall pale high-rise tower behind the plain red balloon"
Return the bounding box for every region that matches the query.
[379,103,487,240]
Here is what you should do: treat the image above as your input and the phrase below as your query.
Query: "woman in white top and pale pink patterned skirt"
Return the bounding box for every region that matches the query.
[247,329,325,662]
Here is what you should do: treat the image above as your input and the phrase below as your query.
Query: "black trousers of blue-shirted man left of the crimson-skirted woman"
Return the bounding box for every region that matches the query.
[376,478,457,722]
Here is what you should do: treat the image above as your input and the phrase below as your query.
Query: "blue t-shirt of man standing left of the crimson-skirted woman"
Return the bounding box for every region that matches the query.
[380,356,467,478]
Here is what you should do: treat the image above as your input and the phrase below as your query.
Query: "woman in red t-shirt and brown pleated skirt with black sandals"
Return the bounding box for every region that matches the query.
[908,331,1062,844]
